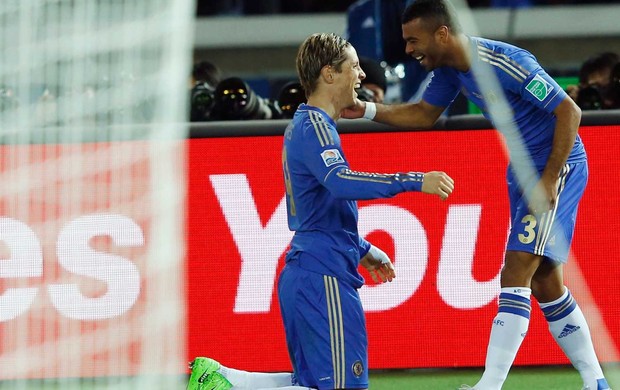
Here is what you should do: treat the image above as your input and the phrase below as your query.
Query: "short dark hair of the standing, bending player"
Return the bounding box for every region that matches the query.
[401,0,462,34]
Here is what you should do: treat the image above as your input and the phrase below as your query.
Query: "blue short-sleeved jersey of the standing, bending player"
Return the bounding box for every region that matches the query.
[423,37,586,168]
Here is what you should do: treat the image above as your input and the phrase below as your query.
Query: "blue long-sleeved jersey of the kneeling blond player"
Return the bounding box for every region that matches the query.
[282,104,424,287]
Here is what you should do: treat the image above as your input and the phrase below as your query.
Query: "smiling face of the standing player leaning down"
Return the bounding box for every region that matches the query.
[402,18,448,71]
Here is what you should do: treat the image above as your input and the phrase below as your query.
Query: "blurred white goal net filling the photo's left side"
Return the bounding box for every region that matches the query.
[0,0,194,389]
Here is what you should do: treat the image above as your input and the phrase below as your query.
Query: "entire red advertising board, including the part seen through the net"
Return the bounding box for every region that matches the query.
[0,126,620,379]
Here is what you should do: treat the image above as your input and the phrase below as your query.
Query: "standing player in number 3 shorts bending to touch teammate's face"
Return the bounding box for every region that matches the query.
[343,0,609,390]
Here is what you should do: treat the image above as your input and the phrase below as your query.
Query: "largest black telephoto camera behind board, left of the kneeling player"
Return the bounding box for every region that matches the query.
[215,77,282,120]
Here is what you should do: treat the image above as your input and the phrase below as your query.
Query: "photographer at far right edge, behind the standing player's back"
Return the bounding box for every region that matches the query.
[566,52,619,110]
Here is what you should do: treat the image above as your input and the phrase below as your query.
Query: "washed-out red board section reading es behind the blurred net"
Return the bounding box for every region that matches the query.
[0,141,154,380]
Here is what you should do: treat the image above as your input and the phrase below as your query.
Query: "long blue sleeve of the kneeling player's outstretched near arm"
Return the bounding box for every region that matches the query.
[302,121,424,200]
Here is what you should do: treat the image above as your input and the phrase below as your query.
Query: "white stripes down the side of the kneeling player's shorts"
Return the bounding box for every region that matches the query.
[323,275,347,389]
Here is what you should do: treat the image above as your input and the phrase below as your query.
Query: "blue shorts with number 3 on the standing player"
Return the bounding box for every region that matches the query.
[506,162,588,263]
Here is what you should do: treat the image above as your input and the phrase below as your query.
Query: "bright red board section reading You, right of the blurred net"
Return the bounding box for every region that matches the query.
[187,126,620,371]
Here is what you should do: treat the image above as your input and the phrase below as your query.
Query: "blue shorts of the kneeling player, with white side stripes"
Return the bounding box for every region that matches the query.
[278,255,368,389]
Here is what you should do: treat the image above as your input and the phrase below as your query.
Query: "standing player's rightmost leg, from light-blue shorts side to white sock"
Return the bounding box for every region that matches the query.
[532,163,609,390]
